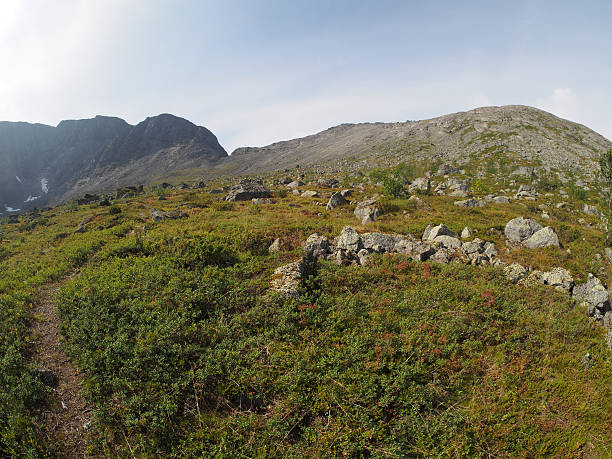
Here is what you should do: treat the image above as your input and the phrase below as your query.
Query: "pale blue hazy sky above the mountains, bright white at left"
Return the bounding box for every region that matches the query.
[0,0,612,152]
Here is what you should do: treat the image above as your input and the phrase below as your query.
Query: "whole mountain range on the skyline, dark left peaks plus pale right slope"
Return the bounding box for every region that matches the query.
[0,105,612,211]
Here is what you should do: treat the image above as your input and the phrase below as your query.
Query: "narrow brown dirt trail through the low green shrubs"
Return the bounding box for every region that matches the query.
[33,279,93,458]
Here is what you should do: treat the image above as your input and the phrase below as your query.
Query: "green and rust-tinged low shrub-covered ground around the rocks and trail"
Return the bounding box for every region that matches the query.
[0,156,612,457]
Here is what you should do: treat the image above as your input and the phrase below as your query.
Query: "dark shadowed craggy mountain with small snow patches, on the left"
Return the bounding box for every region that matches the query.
[0,114,227,210]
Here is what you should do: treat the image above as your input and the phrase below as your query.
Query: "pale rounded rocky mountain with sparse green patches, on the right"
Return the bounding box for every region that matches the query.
[218,105,612,175]
